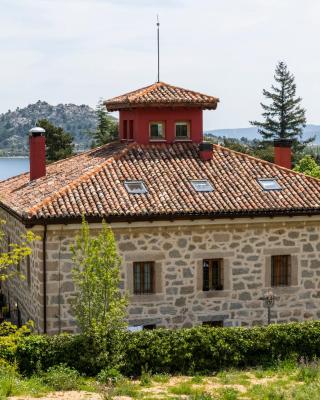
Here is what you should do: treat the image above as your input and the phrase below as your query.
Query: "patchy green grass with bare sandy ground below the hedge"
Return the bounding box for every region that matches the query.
[0,362,320,400]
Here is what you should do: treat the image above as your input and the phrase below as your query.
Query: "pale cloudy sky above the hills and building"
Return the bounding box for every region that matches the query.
[0,0,320,129]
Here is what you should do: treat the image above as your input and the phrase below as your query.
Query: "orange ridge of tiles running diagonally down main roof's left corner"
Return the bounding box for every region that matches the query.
[27,143,136,215]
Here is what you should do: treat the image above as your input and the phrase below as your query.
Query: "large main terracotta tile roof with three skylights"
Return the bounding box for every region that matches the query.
[0,143,320,222]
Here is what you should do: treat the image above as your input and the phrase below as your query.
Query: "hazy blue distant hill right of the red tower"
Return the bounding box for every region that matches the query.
[205,125,320,144]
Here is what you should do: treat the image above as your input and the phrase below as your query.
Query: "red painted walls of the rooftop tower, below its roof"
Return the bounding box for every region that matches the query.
[119,107,203,144]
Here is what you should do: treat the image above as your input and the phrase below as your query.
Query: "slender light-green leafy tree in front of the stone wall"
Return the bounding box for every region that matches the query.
[72,219,127,371]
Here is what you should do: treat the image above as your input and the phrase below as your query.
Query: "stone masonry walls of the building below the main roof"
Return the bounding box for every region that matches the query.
[4,211,320,334]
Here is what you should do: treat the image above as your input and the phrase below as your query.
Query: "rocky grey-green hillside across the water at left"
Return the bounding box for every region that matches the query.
[0,100,105,155]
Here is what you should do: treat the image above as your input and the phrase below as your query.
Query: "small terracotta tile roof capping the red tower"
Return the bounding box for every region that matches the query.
[104,82,219,111]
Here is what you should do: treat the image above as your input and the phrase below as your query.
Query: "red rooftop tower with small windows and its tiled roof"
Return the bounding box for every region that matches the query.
[105,82,219,144]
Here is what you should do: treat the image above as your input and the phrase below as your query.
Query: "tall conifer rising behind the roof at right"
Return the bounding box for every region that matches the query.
[250,61,314,150]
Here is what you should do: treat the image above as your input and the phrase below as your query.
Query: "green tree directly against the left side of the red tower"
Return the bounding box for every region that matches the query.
[91,100,118,147]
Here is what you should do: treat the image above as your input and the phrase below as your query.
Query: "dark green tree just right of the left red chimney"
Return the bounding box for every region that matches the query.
[37,119,74,162]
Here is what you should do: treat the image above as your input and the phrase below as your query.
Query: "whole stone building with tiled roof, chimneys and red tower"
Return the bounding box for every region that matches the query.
[0,82,320,333]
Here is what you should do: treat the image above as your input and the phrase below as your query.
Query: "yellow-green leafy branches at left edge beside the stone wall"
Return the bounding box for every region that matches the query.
[0,220,37,282]
